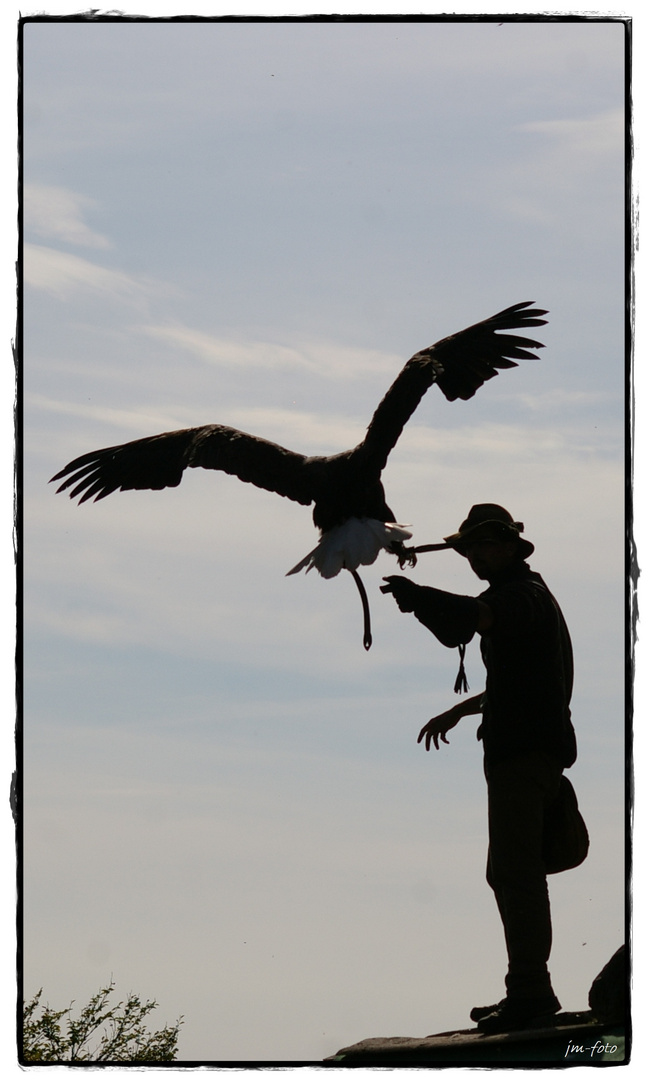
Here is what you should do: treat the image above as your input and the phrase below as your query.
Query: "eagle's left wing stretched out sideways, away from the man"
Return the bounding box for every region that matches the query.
[52,424,313,505]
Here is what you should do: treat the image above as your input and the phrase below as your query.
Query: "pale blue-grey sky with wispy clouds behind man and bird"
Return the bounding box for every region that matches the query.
[15,6,624,1062]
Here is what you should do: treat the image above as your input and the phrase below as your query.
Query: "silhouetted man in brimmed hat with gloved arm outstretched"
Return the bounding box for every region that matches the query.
[383,503,576,1032]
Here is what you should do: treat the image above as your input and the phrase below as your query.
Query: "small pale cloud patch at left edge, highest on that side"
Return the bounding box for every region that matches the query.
[25,184,112,249]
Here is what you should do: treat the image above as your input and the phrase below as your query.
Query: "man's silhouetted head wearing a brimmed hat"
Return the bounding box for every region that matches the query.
[445,502,535,581]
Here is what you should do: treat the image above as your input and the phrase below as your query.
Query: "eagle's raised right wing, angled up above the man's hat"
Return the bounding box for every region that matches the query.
[362,300,546,468]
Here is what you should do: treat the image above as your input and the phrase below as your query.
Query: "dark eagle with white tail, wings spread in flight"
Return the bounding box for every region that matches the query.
[52,301,546,648]
